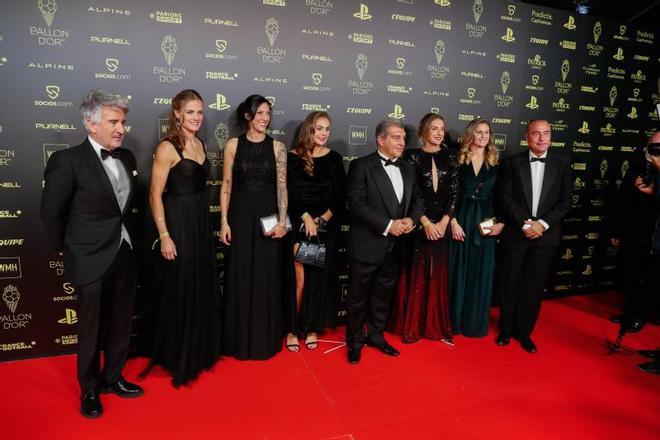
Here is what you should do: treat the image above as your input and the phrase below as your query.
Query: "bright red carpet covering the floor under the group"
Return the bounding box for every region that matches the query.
[0,294,660,440]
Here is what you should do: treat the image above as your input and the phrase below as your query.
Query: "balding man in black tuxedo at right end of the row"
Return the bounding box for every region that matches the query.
[496,120,572,353]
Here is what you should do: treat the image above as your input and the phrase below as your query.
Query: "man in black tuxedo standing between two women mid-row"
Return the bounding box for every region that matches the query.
[346,120,423,364]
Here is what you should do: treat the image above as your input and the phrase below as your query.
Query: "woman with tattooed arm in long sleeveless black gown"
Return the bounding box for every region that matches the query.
[220,95,287,359]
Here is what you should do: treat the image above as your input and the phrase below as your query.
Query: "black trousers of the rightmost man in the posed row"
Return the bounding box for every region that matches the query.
[497,241,557,338]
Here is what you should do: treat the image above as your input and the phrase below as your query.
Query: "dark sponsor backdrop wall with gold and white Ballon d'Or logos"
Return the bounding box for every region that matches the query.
[0,0,660,360]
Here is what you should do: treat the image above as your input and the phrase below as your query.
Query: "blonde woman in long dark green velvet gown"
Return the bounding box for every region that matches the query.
[449,119,504,337]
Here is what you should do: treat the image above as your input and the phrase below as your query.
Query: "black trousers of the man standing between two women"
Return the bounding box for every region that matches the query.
[346,251,399,347]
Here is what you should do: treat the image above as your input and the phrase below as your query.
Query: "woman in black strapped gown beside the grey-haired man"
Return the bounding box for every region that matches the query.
[144,90,220,387]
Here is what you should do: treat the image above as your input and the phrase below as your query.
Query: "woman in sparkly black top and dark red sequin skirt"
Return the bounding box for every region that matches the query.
[390,113,458,345]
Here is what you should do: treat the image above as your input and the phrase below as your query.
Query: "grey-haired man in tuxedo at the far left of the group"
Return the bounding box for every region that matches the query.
[41,89,143,418]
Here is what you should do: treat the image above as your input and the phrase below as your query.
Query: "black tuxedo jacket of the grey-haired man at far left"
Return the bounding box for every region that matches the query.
[41,139,137,285]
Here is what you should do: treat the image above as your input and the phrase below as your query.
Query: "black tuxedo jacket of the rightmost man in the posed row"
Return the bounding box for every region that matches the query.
[497,149,573,249]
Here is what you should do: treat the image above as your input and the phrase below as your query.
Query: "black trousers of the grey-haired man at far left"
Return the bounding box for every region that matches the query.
[76,241,137,394]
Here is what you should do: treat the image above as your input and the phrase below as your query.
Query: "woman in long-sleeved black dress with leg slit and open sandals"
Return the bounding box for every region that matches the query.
[287,112,346,351]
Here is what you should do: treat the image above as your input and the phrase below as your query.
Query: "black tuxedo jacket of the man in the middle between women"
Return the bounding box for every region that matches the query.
[346,152,423,264]
